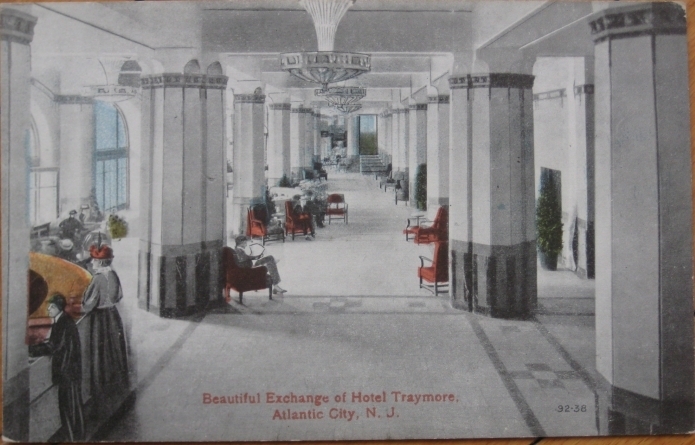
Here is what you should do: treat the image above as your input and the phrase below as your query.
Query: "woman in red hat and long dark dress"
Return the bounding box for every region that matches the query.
[82,245,129,400]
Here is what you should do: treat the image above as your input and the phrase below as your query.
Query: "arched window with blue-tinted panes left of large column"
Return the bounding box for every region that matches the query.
[94,101,128,212]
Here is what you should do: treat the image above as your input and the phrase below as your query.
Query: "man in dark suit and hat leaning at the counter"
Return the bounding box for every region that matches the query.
[29,294,84,442]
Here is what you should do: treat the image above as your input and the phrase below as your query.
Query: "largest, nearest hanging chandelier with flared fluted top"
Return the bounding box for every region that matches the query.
[280,0,371,90]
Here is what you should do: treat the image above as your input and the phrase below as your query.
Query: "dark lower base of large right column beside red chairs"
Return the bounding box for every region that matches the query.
[462,240,537,319]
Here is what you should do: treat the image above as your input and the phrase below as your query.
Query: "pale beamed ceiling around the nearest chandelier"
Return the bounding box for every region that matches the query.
[32,0,591,103]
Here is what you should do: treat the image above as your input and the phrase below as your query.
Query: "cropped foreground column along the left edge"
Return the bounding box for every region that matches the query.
[0,7,36,442]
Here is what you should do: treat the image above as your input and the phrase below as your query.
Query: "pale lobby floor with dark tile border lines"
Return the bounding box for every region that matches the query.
[103,174,597,441]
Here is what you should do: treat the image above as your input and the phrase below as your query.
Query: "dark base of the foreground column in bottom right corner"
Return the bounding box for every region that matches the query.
[596,374,695,435]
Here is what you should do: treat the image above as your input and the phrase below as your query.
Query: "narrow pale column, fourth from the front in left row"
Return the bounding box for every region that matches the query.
[268,103,292,187]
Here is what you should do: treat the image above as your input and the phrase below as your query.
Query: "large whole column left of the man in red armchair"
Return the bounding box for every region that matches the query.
[138,73,228,317]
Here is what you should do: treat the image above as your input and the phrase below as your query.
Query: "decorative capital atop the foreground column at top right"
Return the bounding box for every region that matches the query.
[589,2,686,43]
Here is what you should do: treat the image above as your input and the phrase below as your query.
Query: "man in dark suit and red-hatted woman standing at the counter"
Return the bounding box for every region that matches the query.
[29,241,130,442]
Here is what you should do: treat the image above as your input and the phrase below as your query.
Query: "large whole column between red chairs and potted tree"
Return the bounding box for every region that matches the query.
[448,73,537,318]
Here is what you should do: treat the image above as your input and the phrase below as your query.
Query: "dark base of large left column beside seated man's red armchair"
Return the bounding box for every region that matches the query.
[138,240,223,318]
